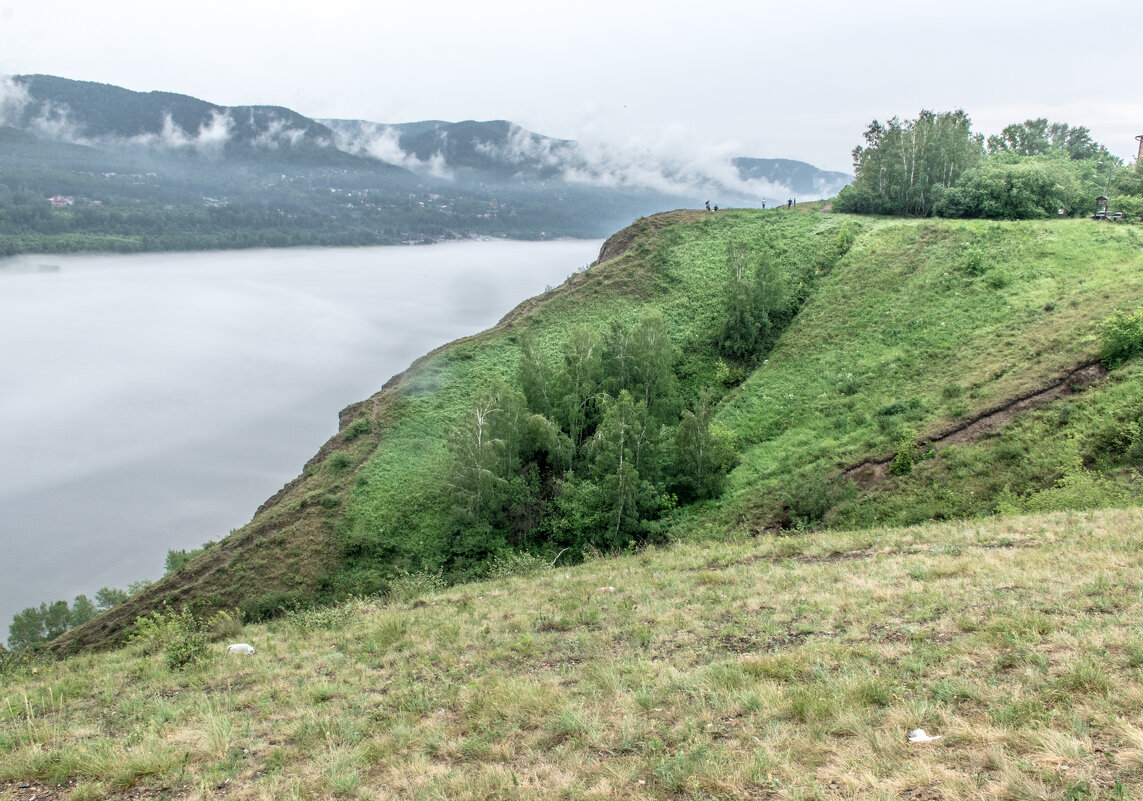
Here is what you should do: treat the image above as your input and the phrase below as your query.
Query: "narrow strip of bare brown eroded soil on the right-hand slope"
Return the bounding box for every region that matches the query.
[841,361,1108,489]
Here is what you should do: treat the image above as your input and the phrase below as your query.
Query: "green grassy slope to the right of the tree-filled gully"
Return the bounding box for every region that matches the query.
[722,221,1143,528]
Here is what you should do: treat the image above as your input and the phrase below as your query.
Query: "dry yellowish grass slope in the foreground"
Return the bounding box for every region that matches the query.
[0,510,1143,801]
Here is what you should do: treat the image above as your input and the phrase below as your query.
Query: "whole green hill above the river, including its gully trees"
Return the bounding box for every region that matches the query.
[54,203,1143,652]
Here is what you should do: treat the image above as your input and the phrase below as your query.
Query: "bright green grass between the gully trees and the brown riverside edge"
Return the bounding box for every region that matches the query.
[338,205,864,591]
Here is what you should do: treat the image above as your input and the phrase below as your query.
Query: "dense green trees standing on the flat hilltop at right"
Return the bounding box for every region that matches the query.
[834,110,1143,219]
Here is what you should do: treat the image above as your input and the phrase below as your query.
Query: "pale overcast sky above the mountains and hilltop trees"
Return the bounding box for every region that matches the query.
[0,0,1143,171]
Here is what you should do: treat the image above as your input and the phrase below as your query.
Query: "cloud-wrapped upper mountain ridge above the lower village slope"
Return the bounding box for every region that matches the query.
[0,74,852,203]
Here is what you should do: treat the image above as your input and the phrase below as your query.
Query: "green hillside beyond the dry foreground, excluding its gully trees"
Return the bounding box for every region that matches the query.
[46,205,1143,652]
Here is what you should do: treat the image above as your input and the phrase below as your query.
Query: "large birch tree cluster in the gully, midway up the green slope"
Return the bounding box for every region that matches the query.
[448,311,736,572]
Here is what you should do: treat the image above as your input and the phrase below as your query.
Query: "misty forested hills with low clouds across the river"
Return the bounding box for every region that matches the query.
[0,75,840,256]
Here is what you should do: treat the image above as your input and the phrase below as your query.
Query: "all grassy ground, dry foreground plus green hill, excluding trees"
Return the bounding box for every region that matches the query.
[13,206,1143,801]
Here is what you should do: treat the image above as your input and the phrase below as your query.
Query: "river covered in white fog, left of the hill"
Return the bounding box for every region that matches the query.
[0,240,600,638]
